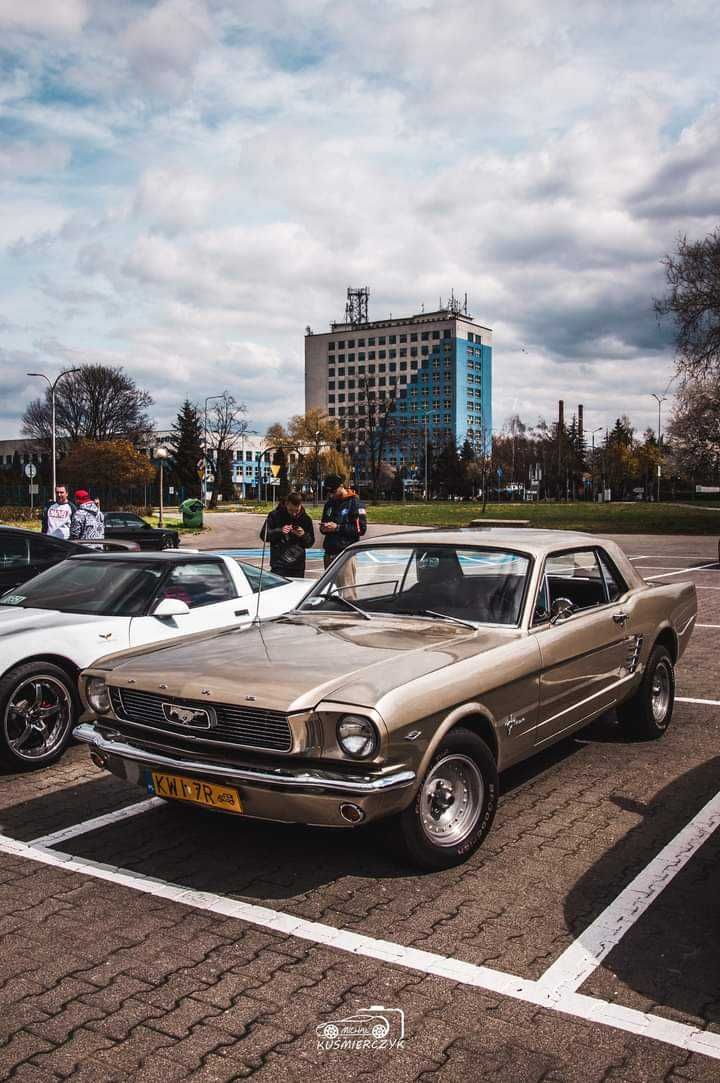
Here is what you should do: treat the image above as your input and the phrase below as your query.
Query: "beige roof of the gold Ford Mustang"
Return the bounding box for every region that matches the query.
[357,526,604,556]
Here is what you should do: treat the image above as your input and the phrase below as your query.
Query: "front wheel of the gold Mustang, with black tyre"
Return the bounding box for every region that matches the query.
[391,727,498,869]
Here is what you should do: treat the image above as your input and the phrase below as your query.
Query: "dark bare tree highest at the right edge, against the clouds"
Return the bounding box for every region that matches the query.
[654,229,720,377]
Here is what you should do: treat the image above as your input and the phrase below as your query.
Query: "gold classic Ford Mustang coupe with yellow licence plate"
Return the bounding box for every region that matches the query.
[75,530,697,869]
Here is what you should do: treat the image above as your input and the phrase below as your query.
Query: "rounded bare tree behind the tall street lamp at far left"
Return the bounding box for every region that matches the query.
[23,365,153,444]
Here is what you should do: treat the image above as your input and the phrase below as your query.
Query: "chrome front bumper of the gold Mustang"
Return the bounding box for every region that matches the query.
[74,722,416,827]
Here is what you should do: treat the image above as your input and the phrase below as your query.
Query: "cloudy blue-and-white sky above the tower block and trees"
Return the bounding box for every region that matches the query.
[0,0,720,438]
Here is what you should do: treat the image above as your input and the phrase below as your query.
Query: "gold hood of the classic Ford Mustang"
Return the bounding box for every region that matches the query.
[93,615,519,710]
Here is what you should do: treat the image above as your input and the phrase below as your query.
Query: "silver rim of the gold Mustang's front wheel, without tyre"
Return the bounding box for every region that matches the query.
[420,755,485,846]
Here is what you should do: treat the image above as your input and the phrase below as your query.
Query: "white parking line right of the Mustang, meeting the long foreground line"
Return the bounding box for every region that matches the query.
[532,788,720,996]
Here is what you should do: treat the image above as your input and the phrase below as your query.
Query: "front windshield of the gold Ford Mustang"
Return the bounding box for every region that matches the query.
[300,544,531,625]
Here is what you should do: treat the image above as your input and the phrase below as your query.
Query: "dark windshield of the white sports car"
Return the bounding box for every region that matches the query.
[0,558,166,616]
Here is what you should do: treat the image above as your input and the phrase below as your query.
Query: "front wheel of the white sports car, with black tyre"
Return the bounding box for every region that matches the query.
[0,662,77,771]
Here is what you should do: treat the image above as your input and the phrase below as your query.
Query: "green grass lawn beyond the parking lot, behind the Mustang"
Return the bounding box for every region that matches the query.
[245,500,720,535]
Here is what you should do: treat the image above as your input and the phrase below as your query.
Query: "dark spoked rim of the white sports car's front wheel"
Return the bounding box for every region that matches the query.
[3,674,73,761]
